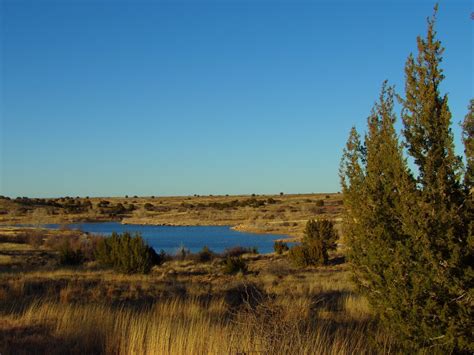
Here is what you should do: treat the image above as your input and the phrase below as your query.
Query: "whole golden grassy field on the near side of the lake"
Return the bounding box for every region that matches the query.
[0,228,392,354]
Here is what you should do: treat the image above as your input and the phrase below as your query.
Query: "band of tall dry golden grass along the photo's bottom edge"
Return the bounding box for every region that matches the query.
[0,292,390,354]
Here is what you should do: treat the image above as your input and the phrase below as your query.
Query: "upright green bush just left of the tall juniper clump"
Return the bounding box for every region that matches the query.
[289,219,337,267]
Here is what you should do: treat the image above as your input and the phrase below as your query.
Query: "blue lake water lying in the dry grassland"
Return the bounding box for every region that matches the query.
[46,222,286,254]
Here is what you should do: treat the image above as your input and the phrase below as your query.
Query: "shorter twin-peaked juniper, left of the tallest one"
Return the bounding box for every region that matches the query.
[341,82,408,326]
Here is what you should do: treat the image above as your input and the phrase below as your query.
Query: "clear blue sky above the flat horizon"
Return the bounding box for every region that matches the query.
[0,0,474,197]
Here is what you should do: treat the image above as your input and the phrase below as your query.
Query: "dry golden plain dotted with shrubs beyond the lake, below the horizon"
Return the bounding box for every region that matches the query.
[0,194,342,241]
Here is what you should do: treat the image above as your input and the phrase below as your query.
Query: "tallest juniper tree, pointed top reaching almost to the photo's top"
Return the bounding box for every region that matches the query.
[399,7,472,350]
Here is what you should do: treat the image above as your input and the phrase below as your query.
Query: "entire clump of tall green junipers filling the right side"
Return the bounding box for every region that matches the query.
[340,6,474,353]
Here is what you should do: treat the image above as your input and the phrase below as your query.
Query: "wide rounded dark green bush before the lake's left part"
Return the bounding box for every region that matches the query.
[95,232,163,274]
